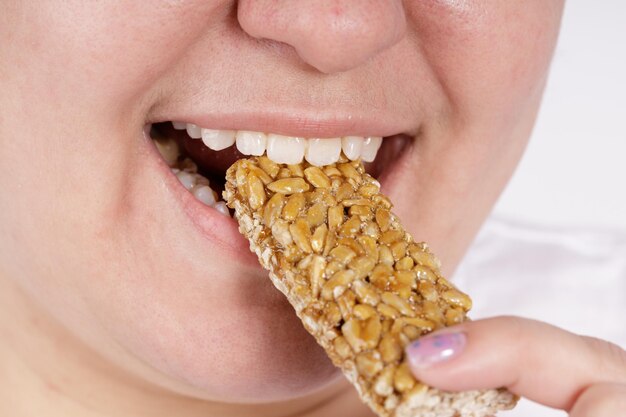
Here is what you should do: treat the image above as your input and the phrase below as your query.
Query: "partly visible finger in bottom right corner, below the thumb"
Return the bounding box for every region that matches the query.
[570,384,626,417]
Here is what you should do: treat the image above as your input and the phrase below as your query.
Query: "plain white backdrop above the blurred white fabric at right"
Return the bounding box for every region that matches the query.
[494,0,626,230]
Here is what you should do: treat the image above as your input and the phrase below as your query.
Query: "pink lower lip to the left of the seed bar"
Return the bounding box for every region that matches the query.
[144,129,259,268]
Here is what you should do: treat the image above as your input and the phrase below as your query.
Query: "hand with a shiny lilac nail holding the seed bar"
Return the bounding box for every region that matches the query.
[407,317,626,417]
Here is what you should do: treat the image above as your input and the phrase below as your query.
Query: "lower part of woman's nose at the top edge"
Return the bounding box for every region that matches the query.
[237,0,406,73]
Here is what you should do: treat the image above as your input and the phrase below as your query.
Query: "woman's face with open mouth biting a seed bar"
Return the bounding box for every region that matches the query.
[0,0,562,402]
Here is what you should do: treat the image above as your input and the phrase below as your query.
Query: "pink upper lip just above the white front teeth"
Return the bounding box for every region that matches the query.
[148,111,417,138]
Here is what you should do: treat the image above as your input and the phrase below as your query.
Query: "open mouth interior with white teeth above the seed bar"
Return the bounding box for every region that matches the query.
[148,121,412,216]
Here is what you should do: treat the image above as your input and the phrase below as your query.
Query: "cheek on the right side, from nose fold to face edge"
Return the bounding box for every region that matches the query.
[387,0,563,268]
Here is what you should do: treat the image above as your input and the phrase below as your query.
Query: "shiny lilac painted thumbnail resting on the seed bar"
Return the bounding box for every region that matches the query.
[406,333,466,369]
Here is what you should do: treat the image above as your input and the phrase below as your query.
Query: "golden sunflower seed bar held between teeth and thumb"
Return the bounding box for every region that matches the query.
[224,156,516,417]
